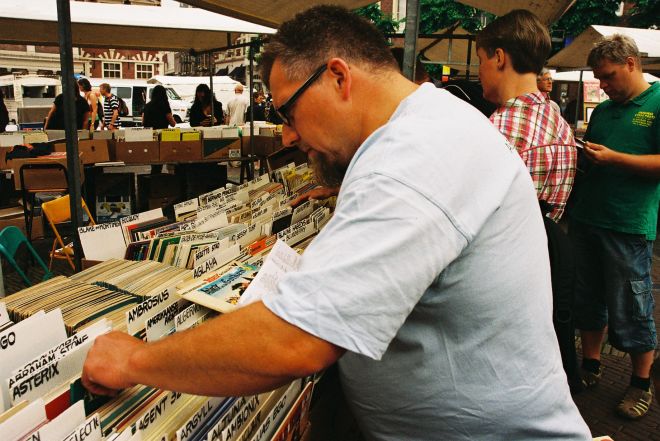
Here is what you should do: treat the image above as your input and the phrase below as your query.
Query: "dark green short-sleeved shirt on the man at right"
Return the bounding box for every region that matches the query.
[569,83,660,240]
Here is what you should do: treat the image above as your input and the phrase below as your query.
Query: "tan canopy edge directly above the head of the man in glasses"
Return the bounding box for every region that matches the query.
[179,0,376,27]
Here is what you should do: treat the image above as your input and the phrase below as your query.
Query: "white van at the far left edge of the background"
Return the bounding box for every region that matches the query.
[0,74,62,128]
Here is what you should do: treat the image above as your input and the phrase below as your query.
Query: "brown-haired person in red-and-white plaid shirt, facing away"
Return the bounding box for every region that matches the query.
[477,10,577,222]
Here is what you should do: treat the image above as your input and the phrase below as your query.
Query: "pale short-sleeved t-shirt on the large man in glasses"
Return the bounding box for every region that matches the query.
[264,84,591,441]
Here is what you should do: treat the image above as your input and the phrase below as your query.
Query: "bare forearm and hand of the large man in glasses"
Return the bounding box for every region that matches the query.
[83,302,345,396]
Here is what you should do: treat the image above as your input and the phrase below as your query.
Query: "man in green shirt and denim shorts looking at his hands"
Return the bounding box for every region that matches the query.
[569,35,660,419]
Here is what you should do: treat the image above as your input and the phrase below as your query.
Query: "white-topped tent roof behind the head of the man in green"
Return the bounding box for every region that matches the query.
[548,25,660,71]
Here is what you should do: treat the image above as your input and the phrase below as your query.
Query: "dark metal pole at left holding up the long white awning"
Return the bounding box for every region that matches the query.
[57,0,82,272]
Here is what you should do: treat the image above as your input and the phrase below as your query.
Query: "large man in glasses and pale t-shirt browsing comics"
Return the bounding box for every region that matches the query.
[83,6,591,441]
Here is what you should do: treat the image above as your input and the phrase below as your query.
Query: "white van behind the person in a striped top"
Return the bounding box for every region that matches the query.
[89,78,190,125]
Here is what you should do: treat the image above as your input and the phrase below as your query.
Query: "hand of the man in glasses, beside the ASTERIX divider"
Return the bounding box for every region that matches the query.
[82,332,146,395]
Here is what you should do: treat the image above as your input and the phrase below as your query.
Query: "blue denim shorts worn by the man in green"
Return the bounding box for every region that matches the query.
[569,220,657,353]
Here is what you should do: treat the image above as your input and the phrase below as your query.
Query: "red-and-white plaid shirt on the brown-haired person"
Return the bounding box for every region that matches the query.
[490,92,577,222]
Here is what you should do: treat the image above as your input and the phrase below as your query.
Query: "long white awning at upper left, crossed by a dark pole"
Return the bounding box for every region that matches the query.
[0,0,275,52]
